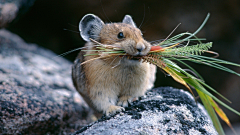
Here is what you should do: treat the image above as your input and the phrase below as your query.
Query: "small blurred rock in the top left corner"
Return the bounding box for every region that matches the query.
[0,0,35,28]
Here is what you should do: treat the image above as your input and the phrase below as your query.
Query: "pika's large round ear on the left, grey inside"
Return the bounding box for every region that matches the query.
[79,14,104,41]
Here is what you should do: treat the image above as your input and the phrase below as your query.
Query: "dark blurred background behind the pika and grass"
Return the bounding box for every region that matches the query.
[7,0,240,129]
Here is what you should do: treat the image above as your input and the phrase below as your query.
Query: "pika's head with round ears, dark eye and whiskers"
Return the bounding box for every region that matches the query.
[79,14,151,56]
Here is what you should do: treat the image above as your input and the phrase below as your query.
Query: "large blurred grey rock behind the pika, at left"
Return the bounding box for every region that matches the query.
[0,30,91,134]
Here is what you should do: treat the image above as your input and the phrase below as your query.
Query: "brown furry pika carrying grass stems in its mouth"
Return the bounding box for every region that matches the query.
[72,14,156,117]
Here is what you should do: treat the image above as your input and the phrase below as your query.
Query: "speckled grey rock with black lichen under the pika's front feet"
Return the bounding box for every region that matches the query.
[75,87,217,135]
